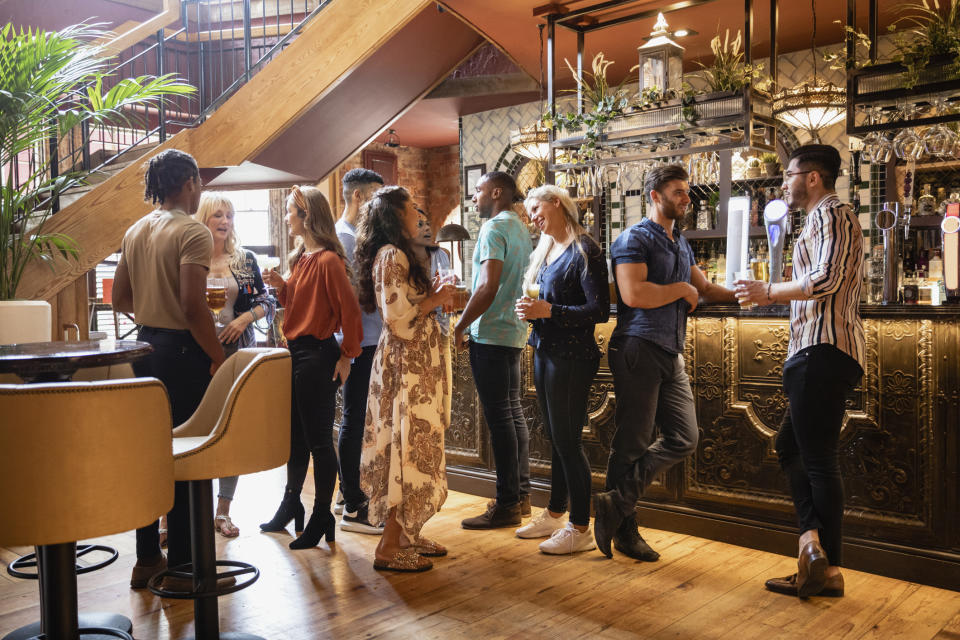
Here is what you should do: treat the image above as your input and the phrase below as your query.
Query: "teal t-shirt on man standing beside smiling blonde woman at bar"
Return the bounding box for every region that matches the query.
[470,211,533,348]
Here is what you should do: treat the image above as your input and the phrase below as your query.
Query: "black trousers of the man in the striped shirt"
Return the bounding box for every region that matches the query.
[776,344,863,567]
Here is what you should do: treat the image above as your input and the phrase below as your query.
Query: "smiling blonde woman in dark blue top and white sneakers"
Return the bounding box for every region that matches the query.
[517,185,610,554]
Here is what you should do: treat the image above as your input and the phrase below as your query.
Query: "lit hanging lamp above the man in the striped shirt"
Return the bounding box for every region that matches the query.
[773,0,847,142]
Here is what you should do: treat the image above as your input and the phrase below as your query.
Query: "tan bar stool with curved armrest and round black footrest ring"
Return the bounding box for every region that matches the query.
[148,349,290,640]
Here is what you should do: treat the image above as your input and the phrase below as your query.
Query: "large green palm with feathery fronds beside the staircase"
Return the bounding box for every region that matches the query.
[0,23,195,300]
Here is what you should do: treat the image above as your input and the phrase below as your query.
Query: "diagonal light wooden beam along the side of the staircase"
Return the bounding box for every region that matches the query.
[17,0,434,299]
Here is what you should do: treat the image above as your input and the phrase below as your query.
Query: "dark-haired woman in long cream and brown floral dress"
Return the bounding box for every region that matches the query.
[356,186,453,571]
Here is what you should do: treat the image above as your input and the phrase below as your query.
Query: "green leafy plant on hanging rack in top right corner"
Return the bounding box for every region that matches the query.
[890,0,960,89]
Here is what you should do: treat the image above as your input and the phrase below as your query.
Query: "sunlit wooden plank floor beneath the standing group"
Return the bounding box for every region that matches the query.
[0,470,960,640]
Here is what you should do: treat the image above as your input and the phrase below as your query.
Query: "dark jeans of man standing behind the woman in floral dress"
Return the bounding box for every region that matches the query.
[337,344,377,511]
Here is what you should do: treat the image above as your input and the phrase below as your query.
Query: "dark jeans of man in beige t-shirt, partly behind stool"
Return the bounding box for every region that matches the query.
[133,327,210,567]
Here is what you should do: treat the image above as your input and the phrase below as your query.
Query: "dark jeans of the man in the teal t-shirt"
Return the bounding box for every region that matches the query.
[470,342,530,506]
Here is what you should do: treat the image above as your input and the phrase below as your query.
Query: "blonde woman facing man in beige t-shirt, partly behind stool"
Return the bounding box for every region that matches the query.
[188,191,277,538]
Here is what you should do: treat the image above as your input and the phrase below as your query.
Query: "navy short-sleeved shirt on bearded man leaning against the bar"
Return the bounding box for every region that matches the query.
[610,218,696,353]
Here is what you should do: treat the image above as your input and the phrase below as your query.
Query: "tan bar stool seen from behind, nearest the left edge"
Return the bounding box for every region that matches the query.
[0,378,173,640]
